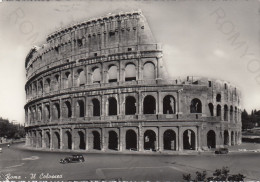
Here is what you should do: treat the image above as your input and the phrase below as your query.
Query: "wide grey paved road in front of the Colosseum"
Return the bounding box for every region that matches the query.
[0,144,260,181]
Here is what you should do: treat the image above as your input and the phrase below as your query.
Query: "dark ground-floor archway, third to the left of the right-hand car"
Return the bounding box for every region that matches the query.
[163,130,176,150]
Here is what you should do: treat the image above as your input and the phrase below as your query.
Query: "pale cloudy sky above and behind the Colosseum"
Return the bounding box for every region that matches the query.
[0,0,260,123]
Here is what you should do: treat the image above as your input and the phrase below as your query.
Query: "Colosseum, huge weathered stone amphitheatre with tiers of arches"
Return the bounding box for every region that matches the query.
[24,11,241,153]
